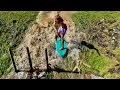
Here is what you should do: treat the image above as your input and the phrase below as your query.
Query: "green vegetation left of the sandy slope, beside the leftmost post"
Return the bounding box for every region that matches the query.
[0,11,38,76]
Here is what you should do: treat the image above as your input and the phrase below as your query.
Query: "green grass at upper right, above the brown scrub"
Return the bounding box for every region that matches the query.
[72,11,120,32]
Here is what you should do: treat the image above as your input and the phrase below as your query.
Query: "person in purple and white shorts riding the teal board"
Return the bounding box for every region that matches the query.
[54,12,67,50]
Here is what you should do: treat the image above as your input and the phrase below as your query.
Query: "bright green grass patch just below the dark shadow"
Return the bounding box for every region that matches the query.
[81,50,117,76]
